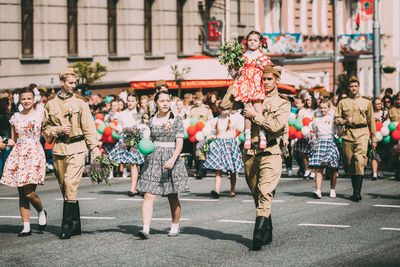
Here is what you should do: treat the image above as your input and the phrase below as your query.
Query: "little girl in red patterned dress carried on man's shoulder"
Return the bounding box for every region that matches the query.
[223,31,272,149]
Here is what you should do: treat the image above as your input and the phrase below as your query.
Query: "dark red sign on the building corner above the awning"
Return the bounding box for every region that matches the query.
[203,18,222,56]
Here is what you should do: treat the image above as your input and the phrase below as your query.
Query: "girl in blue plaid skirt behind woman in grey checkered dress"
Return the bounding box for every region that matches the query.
[110,94,144,196]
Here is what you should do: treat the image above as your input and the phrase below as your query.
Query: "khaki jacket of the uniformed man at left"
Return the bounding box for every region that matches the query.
[43,94,99,156]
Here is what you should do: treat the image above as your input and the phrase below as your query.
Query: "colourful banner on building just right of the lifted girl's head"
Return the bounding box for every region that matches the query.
[263,33,303,55]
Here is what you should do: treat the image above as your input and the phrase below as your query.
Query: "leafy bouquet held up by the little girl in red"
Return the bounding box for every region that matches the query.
[218,36,246,69]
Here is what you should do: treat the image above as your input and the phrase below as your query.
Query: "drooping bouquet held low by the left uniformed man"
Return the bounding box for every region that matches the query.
[83,154,118,185]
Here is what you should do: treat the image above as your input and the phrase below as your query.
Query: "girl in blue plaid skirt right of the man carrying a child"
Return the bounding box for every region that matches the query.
[308,99,340,199]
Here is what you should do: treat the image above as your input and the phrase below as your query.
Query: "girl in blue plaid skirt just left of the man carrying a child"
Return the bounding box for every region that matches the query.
[203,106,244,198]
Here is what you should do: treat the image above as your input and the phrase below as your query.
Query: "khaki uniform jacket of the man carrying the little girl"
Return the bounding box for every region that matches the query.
[221,87,291,154]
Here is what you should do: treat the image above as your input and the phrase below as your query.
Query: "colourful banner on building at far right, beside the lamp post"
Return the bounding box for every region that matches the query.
[339,33,373,53]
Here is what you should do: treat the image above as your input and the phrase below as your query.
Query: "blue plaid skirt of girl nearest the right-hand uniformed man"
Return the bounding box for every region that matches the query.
[308,137,340,168]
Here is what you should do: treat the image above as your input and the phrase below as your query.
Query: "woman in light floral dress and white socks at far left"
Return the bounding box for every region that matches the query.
[0,88,51,236]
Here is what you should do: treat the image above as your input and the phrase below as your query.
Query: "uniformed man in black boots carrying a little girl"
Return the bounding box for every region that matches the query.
[221,65,290,250]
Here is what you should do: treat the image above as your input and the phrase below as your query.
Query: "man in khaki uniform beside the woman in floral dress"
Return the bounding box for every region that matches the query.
[43,68,100,239]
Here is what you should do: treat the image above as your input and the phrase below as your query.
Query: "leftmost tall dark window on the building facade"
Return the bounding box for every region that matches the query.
[21,0,33,57]
